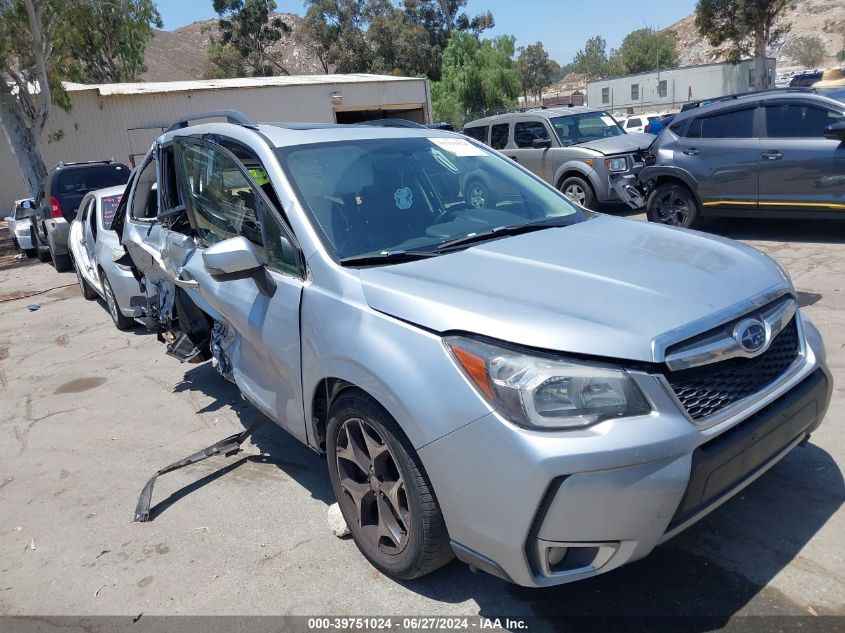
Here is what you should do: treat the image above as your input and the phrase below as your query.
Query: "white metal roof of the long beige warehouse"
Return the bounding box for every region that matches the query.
[64,73,423,97]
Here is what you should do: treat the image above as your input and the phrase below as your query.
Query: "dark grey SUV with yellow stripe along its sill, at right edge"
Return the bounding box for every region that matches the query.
[638,89,845,227]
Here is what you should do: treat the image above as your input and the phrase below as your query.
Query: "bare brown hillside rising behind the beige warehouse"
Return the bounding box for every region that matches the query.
[141,13,323,81]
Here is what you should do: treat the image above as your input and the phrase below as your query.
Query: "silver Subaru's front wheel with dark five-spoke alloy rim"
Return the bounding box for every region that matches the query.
[326,390,454,580]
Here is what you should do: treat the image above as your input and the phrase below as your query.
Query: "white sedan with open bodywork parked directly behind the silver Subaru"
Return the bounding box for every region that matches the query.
[68,185,145,330]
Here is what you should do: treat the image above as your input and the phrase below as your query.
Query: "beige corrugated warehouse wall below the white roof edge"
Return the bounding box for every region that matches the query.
[0,80,431,212]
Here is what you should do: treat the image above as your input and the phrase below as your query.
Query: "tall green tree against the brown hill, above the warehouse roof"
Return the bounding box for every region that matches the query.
[209,0,291,77]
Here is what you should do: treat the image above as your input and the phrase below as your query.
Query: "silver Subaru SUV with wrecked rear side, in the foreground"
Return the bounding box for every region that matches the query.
[115,108,832,587]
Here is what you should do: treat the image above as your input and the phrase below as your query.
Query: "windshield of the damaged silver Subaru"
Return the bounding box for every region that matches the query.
[276,136,584,259]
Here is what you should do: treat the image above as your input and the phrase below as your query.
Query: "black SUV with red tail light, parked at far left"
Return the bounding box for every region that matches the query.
[32,160,130,272]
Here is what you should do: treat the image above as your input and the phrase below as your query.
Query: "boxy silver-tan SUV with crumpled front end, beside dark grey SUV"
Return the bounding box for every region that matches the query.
[462,106,654,209]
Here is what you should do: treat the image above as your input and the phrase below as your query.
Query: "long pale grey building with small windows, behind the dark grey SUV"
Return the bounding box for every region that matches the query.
[587,58,776,114]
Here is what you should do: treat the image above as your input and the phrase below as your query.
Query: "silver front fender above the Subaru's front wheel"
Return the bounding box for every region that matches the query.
[300,279,491,448]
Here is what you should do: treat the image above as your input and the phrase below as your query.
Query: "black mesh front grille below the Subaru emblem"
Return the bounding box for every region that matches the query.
[665,317,800,420]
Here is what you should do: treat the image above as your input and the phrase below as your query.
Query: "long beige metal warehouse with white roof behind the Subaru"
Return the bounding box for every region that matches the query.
[0,74,431,210]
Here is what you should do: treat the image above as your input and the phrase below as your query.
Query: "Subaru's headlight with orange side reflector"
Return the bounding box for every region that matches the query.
[444,336,651,429]
